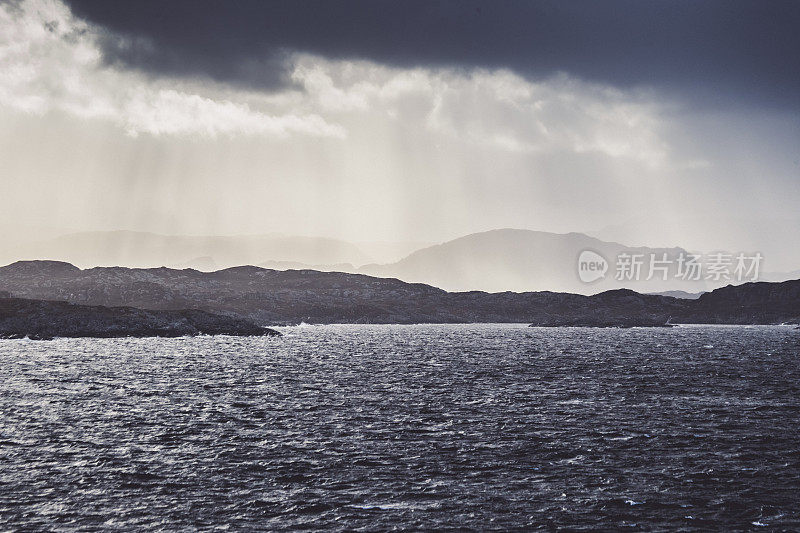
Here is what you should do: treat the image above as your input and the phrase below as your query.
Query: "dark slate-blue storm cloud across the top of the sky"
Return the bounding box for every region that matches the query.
[69,0,800,107]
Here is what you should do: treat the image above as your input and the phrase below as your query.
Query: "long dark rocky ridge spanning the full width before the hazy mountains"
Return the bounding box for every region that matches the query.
[0,261,800,326]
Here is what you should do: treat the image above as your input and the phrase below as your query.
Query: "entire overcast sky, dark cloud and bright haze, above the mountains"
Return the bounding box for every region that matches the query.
[0,0,800,268]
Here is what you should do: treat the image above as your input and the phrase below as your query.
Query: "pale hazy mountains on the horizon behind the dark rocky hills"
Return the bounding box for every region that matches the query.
[0,229,800,294]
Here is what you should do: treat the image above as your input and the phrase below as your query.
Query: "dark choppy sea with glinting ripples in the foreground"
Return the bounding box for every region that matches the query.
[0,325,800,531]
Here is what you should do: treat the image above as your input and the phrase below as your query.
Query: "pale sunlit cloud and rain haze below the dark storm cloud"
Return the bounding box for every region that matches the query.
[0,0,800,265]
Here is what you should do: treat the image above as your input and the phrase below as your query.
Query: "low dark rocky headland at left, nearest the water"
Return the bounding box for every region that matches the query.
[0,297,280,340]
